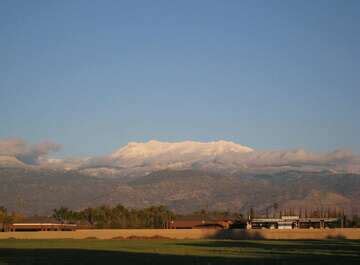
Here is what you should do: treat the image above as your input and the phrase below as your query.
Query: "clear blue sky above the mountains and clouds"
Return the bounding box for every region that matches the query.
[0,0,360,156]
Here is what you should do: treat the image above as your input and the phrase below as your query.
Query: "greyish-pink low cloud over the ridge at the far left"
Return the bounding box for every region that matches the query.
[0,138,61,164]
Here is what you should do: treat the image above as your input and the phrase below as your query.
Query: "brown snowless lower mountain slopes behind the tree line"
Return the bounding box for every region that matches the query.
[0,168,360,214]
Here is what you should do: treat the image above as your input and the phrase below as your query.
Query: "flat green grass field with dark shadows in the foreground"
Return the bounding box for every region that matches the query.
[0,239,360,265]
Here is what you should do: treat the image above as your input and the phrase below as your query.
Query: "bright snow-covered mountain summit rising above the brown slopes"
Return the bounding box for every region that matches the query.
[82,140,254,175]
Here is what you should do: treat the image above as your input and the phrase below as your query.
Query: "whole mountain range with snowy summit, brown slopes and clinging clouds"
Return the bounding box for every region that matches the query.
[0,139,360,215]
